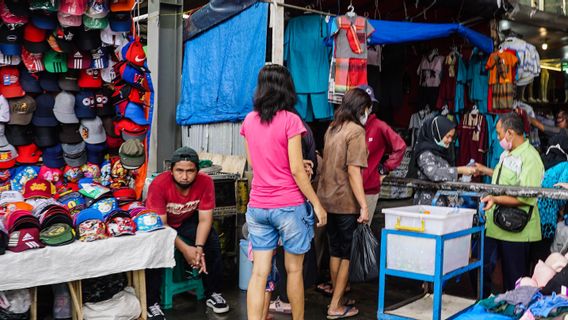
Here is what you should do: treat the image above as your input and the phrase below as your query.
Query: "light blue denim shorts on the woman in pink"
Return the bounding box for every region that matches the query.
[247,202,314,254]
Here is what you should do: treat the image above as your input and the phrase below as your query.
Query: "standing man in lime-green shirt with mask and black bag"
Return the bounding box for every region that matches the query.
[476,113,544,296]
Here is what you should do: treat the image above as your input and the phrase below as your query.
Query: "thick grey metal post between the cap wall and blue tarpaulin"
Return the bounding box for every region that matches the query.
[147,0,183,174]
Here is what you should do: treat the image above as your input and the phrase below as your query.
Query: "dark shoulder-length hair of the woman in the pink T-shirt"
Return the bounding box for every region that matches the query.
[253,64,296,124]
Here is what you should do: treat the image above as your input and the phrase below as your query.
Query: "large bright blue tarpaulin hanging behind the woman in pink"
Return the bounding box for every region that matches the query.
[176,3,268,125]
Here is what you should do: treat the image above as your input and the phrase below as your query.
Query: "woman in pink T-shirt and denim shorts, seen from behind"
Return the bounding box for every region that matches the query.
[241,65,327,320]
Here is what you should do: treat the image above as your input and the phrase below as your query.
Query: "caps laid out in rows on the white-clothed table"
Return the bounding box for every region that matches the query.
[0,178,163,254]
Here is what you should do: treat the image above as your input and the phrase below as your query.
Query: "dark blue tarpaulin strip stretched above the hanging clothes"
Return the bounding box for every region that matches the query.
[369,19,493,53]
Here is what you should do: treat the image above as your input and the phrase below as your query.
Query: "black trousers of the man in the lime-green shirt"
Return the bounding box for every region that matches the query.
[483,237,530,297]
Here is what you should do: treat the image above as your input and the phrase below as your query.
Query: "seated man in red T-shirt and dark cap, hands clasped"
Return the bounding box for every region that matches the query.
[146,147,229,320]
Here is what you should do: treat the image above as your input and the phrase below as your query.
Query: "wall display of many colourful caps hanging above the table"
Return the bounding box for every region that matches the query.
[0,0,152,185]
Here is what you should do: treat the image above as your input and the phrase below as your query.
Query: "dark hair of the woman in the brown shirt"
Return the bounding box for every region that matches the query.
[331,88,372,132]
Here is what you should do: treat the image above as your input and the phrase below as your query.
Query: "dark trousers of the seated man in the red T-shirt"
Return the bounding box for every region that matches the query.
[146,214,223,306]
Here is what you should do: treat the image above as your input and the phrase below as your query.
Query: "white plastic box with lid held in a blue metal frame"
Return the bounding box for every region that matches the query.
[383,205,476,275]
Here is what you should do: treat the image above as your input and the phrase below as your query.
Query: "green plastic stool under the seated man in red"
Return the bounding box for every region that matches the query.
[161,240,205,310]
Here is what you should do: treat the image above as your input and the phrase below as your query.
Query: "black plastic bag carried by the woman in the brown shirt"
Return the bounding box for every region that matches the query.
[349,223,379,282]
